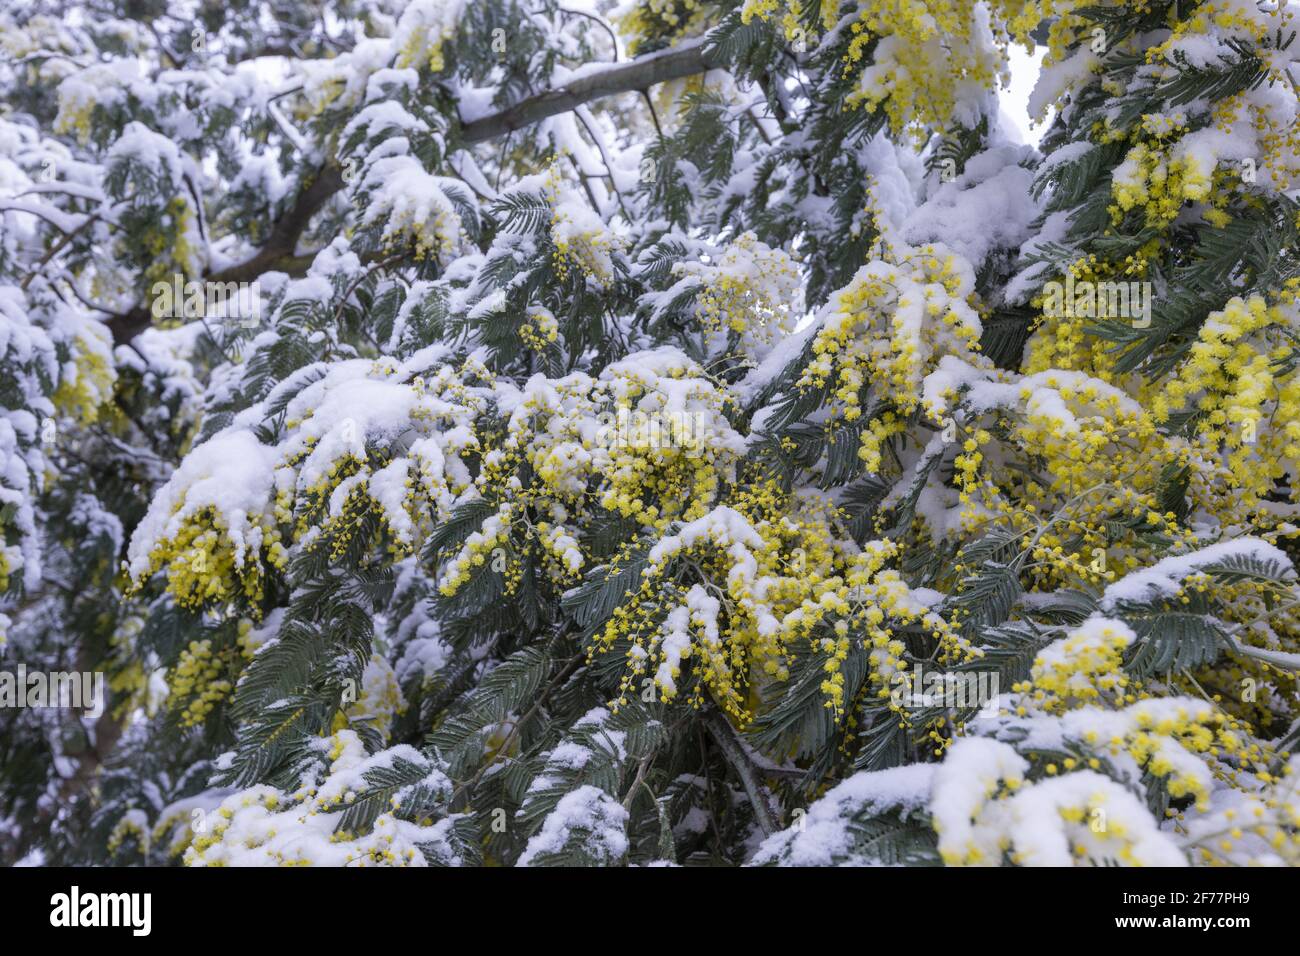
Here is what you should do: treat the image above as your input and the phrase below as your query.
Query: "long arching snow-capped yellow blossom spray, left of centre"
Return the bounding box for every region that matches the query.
[131,349,745,613]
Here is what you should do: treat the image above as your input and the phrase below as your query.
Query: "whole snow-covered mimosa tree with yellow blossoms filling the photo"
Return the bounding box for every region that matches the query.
[0,0,1300,866]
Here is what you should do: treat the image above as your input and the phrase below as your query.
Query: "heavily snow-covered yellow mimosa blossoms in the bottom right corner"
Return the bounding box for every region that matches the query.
[932,606,1297,865]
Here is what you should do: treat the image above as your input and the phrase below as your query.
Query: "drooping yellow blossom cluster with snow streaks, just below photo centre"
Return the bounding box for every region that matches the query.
[592,481,966,723]
